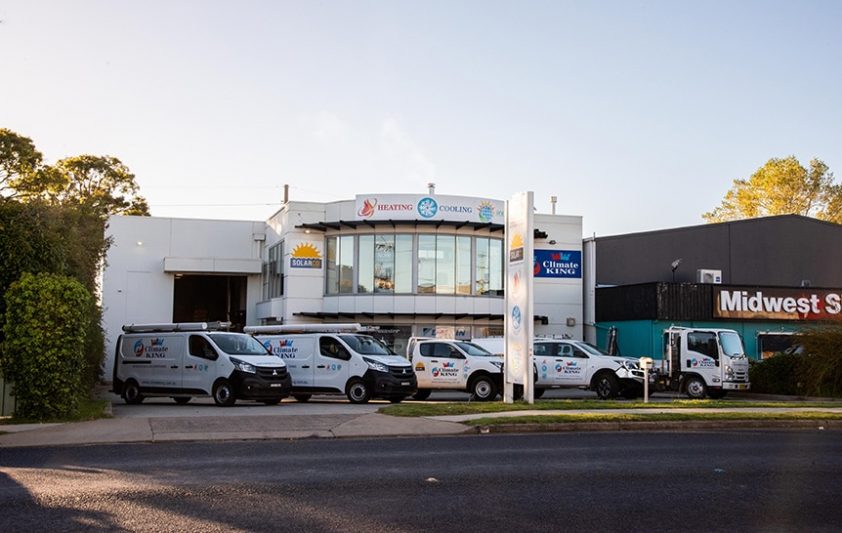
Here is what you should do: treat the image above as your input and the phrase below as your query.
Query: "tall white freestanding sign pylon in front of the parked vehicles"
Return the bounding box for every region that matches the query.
[503,191,535,403]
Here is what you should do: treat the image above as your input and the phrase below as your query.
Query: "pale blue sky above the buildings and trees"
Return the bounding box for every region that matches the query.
[0,0,842,236]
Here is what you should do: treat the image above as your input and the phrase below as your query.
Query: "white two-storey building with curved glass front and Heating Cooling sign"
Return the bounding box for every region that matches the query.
[102,194,582,379]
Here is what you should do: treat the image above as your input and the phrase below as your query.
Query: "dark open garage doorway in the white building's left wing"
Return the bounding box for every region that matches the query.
[173,274,248,331]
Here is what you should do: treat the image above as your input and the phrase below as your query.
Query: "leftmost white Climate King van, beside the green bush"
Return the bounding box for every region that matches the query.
[112,322,292,406]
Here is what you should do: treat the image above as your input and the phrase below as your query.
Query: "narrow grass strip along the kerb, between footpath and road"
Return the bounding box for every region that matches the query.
[463,411,842,426]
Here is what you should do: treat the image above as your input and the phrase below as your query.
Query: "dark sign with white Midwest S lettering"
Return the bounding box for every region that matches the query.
[713,287,842,321]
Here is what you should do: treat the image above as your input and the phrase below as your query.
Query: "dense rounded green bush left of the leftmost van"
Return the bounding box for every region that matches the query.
[0,273,96,420]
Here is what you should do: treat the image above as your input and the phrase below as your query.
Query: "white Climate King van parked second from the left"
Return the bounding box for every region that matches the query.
[245,324,417,403]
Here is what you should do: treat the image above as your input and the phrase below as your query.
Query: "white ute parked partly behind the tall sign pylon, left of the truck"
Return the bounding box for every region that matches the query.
[473,337,643,400]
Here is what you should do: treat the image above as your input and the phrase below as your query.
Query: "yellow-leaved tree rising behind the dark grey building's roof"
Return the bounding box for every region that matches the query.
[702,156,842,223]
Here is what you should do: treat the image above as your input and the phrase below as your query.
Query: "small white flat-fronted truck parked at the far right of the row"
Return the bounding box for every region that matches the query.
[655,326,751,399]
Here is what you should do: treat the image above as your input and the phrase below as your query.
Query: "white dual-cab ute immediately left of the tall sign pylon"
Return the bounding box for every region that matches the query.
[406,337,503,402]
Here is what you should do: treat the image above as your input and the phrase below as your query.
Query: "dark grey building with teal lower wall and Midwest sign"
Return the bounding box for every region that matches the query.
[584,215,842,359]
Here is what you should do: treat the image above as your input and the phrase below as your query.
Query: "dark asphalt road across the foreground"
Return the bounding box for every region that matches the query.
[0,431,842,532]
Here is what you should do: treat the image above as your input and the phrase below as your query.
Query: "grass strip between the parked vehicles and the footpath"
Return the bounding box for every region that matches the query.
[379,400,842,416]
